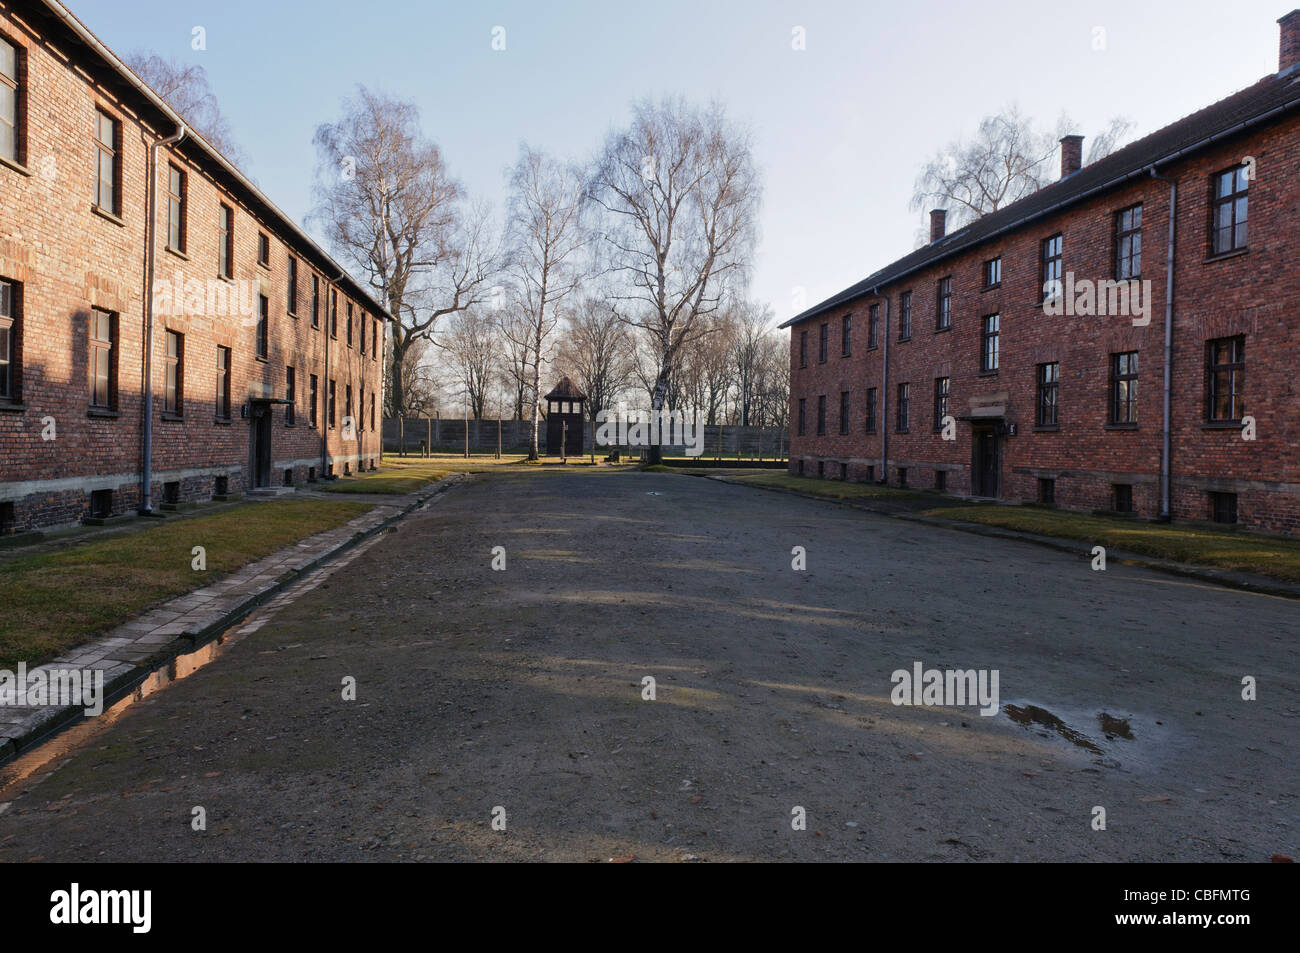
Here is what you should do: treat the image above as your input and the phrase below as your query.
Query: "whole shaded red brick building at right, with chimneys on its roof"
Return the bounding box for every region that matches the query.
[784,10,1300,533]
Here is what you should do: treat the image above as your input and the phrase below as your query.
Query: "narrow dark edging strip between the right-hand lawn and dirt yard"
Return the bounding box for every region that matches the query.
[706,475,1300,599]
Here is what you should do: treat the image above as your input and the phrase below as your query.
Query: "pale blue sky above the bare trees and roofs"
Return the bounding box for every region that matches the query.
[66,0,1295,321]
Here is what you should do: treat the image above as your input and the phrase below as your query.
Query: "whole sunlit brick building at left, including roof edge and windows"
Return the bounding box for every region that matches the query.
[0,0,389,532]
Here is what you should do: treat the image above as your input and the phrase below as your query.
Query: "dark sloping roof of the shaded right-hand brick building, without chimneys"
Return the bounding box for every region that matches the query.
[781,68,1300,328]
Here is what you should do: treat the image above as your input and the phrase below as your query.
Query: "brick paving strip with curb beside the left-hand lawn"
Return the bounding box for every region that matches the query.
[0,473,467,766]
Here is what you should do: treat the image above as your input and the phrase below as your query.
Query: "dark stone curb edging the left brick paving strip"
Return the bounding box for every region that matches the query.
[0,473,468,767]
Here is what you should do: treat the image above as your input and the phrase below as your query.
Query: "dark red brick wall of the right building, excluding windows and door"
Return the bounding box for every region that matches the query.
[790,106,1300,533]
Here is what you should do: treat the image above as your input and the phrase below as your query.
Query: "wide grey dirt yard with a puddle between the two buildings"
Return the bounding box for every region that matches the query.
[0,471,1300,861]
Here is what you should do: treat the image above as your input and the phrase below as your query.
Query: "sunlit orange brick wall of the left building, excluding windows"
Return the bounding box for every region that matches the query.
[0,4,384,530]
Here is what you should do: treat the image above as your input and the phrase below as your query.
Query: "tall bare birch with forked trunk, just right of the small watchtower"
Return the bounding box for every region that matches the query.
[589,99,761,463]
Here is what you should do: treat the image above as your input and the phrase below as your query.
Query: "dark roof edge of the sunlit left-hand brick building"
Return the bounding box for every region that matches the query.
[33,0,393,321]
